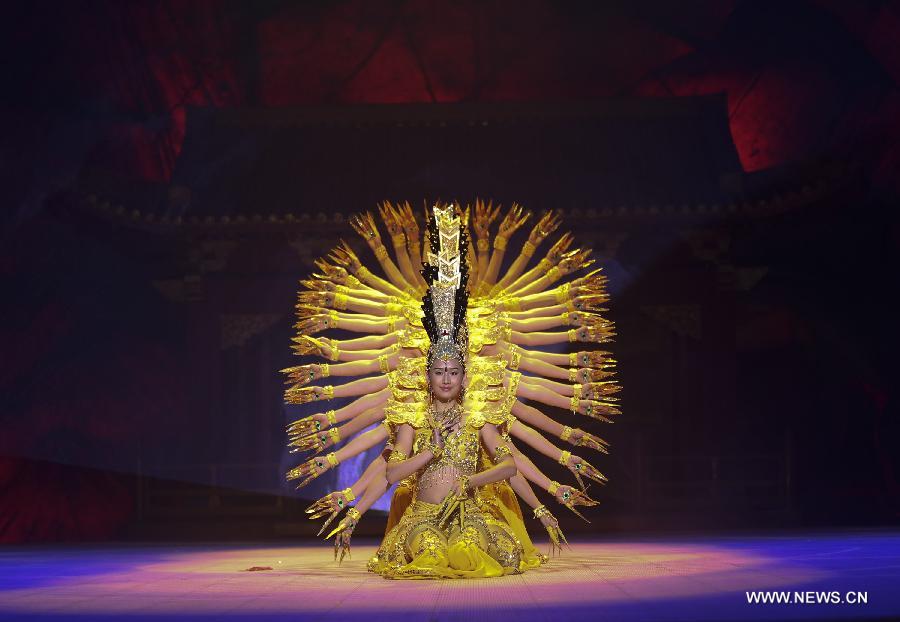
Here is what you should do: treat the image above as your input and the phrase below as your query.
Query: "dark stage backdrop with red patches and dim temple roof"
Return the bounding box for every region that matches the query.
[0,0,900,543]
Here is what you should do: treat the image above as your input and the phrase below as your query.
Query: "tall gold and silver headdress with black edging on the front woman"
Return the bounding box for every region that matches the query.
[422,204,469,369]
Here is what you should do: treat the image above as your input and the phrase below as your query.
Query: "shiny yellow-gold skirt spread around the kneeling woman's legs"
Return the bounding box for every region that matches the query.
[368,485,546,579]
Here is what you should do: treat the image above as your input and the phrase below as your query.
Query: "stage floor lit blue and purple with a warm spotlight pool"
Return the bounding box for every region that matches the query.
[0,531,900,622]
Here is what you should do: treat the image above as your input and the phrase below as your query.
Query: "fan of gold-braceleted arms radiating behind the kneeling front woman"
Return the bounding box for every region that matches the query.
[281,200,621,559]
